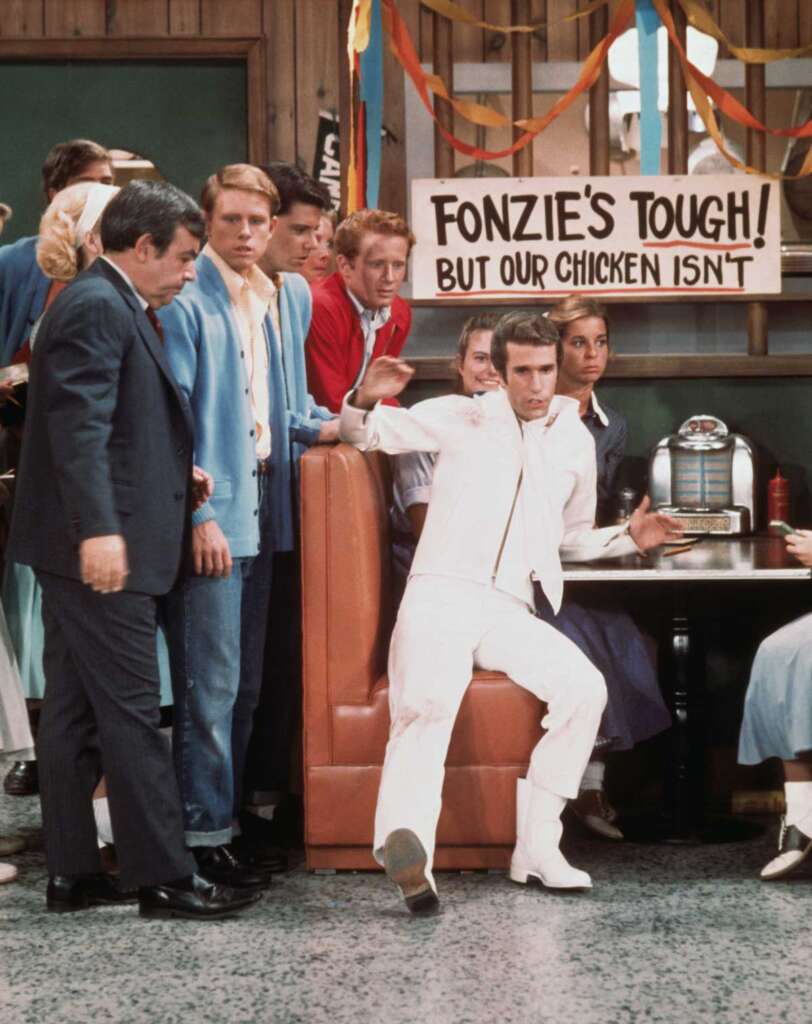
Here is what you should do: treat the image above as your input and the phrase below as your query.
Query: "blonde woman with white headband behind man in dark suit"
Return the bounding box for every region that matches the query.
[2,181,119,796]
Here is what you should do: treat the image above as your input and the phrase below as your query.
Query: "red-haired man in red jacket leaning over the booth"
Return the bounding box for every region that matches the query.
[305,210,415,413]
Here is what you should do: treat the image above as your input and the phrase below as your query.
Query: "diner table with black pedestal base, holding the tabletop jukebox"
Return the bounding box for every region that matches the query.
[563,536,812,843]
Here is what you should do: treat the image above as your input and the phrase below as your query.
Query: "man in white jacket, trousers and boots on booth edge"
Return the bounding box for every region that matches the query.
[340,312,677,912]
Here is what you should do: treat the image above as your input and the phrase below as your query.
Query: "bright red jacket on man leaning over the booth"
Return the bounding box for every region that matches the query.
[304,271,412,413]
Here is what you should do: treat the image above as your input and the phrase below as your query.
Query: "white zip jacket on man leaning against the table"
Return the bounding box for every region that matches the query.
[339,390,638,611]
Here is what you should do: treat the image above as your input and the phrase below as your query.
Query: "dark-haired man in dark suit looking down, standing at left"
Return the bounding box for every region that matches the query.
[9,181,259,918]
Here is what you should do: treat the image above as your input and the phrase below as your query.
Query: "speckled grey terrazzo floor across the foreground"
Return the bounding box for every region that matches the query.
[0,795,812,1024]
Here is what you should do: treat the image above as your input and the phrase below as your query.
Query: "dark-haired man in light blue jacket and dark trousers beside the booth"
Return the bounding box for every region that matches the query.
[234,163,338,862]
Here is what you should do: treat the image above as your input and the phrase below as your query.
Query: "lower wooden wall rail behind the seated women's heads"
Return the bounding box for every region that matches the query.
[407,355,812,381]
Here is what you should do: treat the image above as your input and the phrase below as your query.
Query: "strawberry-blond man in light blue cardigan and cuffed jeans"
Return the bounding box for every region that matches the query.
[161,164,331,888]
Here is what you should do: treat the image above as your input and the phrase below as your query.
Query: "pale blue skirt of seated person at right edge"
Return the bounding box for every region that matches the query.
[738,615,812,765]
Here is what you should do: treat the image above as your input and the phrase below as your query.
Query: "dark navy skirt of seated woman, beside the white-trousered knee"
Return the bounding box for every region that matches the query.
[543,600,671,751]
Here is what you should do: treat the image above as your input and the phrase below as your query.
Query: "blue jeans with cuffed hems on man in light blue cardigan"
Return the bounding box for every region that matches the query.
[166,476,273,846]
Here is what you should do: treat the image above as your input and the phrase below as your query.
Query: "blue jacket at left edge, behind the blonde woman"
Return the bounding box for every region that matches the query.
[0,236,50,367]
